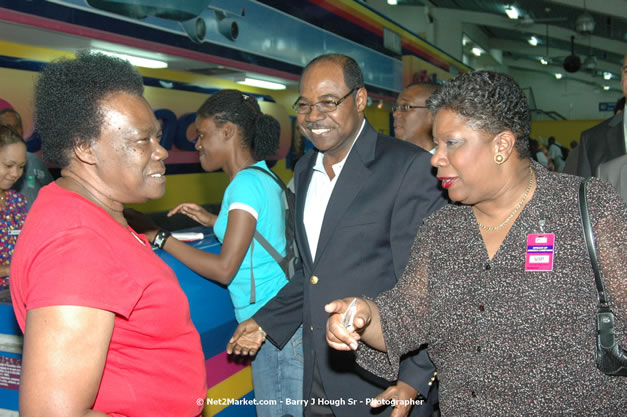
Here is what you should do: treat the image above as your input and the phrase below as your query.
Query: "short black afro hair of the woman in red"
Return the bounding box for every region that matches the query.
[35,51,144,168]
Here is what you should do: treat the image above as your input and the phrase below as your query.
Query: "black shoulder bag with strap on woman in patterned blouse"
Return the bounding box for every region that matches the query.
[579,178,627,376]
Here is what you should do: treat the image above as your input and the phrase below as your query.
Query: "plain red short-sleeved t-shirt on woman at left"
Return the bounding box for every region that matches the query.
[11,183,207,417]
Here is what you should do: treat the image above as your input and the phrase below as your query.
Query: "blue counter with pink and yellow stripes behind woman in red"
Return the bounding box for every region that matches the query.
[0,228,256,417]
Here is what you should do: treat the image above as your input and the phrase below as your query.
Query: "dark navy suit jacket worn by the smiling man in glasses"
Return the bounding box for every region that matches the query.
[254,122,446,417]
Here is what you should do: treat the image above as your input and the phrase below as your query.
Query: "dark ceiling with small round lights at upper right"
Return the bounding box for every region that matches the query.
[365,0,627,91]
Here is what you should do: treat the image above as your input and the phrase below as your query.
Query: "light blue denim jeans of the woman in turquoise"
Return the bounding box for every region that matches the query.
[252,326,303,417]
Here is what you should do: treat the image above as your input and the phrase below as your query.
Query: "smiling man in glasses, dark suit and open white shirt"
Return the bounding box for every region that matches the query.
[227,55,445,417]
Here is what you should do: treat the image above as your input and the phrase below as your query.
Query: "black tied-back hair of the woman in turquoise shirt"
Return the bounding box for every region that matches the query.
[196,90,281,161]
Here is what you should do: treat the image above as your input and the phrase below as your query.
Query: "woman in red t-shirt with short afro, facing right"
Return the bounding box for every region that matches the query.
[11,52,207,417]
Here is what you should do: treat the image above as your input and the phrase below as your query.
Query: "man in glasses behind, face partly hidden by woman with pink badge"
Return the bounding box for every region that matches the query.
[392,82,438,154]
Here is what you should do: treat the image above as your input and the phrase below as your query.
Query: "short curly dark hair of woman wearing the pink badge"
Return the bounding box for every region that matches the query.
[427,71,531,158]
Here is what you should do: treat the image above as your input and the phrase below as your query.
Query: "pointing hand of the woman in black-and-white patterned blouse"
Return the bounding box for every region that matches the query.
[324,297,372,350]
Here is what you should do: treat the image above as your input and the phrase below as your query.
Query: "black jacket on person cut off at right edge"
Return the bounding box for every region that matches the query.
[577,112,627,177]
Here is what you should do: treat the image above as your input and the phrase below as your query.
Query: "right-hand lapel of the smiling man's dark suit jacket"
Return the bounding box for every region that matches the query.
[314,122,377,267]
